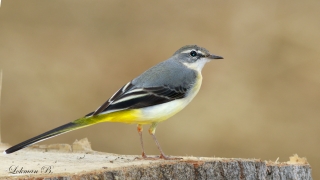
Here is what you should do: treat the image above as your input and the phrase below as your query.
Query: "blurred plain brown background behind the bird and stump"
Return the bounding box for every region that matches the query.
[0,0,320,179]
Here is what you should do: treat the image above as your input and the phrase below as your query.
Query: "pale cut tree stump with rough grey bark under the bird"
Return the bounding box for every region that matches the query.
[0,139,312,180]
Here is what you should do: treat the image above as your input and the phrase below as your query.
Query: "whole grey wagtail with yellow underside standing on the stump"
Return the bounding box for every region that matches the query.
[4,45,223,159]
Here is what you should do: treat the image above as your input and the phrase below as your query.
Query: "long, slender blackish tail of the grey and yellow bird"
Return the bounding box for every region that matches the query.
[3,122,86,154]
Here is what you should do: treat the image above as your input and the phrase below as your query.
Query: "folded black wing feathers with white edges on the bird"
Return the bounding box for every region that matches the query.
[86,82,187,116]
